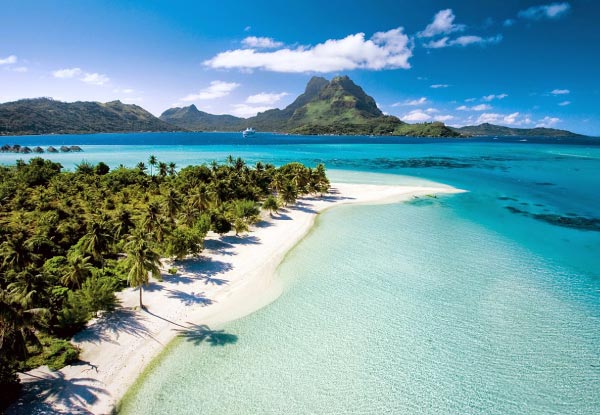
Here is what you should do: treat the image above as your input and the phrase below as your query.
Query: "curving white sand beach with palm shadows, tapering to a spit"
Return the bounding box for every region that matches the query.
[8,184,461,414]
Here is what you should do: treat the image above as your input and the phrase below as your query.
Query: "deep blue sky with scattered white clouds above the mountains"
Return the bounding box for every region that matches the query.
[0,0,600,136]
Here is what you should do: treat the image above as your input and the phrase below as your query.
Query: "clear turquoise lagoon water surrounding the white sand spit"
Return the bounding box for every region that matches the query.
[0,133,600,414]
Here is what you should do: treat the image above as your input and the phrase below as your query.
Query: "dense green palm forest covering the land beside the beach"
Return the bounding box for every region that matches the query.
[0,156,329,408]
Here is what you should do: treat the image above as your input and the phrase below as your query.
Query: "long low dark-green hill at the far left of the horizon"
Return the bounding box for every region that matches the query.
[0,98,182,135]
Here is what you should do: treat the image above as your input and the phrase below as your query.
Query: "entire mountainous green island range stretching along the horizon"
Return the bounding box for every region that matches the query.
[0,76,582,138]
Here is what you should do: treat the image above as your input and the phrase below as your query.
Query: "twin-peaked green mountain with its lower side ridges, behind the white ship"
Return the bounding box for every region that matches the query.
[160,76,461,137]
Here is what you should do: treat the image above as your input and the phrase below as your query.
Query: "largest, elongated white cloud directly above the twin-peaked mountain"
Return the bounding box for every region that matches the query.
[204,28,412,73]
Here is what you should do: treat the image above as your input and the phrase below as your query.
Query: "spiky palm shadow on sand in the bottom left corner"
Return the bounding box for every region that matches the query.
[7,368,107,415]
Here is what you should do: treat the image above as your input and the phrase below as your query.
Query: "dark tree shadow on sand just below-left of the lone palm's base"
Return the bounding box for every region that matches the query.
[74,309,152,344]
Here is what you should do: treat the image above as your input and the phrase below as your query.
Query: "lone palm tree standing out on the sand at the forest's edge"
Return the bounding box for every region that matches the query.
[125,231,161,308]
